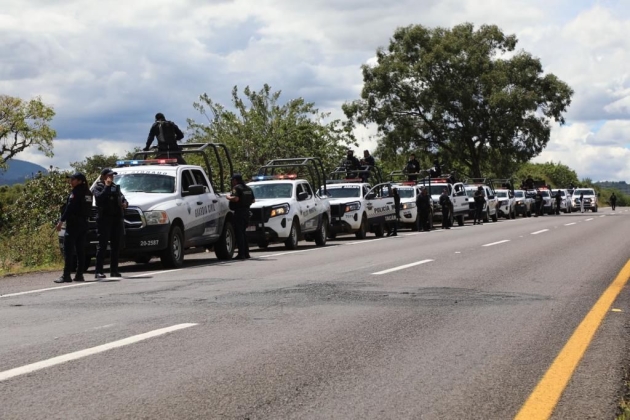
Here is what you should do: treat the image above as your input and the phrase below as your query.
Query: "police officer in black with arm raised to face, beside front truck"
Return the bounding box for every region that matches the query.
[92,168,129,280]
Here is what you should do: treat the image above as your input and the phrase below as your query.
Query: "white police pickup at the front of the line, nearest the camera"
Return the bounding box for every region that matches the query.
[108,159,235,267]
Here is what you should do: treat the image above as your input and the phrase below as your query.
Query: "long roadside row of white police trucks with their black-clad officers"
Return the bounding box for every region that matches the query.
[55,144,617,276]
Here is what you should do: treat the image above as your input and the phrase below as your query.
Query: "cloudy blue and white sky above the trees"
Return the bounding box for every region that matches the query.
[0,0,630,182]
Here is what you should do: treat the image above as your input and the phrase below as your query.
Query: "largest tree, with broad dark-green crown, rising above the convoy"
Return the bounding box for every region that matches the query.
[343,23,573,177]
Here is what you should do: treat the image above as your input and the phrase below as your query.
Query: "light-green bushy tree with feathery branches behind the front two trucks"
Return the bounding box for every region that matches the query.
[188,84,354,176]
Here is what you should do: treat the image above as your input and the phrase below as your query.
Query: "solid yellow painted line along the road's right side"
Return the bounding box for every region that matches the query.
[515,261,630,420]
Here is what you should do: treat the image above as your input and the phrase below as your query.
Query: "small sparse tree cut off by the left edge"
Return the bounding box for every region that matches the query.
[0,95,57,168]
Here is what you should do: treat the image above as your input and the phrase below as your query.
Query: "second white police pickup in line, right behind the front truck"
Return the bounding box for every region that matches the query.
[247,158,331,249]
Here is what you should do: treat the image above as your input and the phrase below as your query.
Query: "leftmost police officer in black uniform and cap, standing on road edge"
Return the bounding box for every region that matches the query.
[55,172,92,283]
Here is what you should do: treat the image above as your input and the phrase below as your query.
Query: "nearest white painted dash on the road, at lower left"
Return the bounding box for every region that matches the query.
[0,324,197,382]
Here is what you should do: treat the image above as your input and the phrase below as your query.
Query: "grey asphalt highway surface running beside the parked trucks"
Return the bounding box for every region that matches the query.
[0,208,630,420]
